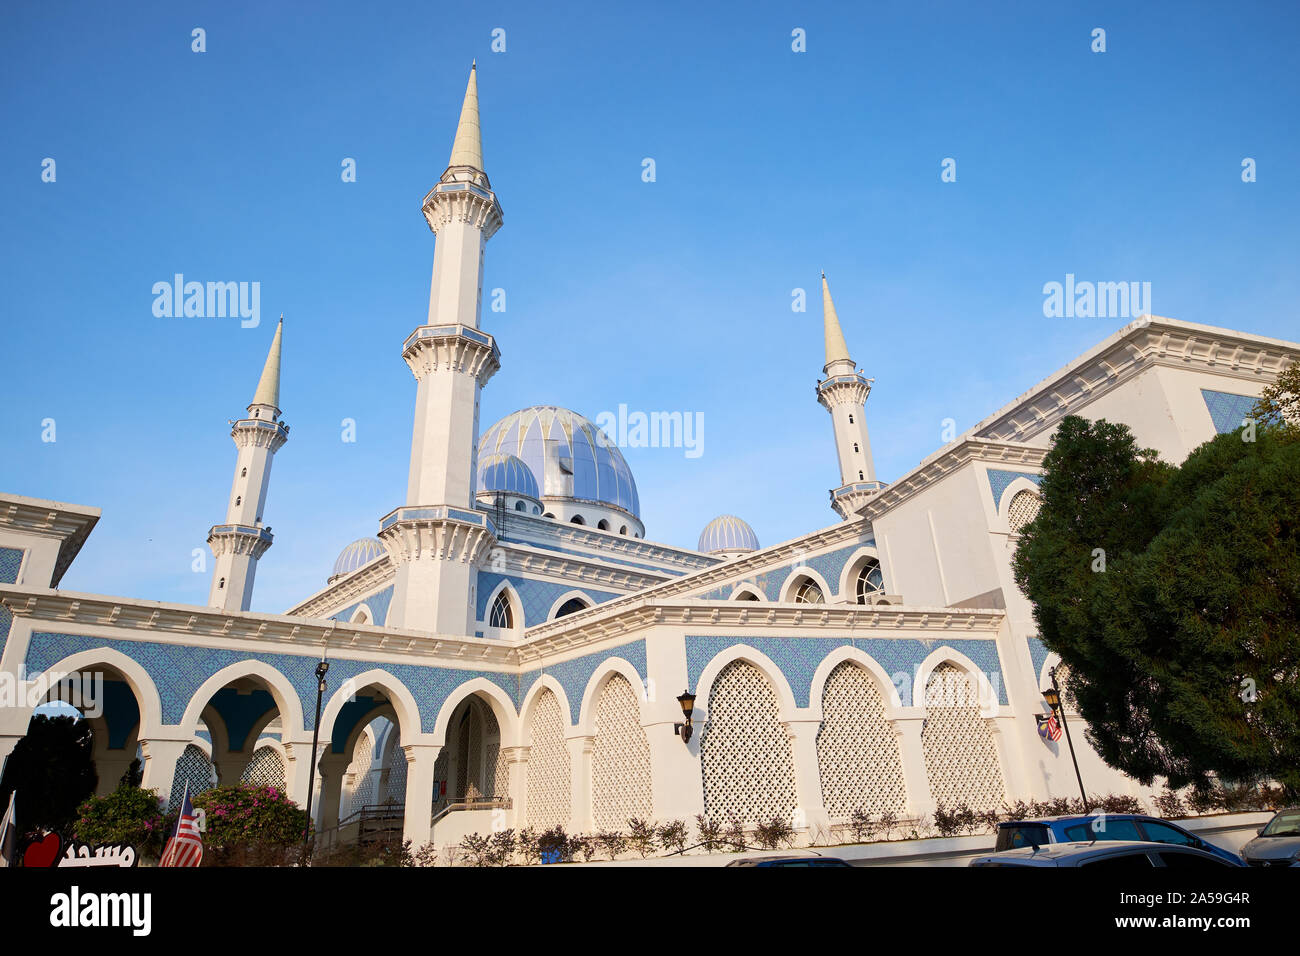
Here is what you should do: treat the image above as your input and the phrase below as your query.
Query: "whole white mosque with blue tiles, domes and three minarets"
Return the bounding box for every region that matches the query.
[0,72,1300,847]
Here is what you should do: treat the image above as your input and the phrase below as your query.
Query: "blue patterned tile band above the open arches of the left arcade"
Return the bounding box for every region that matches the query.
[27,632,519,732]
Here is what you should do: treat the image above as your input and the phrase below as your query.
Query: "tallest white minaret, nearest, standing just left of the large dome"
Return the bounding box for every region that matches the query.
[380,66,502,635]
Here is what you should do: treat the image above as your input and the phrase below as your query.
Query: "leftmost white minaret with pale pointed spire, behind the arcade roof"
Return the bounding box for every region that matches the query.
[208,316,289,611]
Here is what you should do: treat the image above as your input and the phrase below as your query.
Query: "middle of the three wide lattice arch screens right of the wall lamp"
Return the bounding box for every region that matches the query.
[816,662,907,821]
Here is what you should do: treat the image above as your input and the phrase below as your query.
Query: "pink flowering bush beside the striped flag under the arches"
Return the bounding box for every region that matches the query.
[194,784,307,866]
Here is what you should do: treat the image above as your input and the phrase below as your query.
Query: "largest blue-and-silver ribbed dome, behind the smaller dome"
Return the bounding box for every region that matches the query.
[478,405,641,519]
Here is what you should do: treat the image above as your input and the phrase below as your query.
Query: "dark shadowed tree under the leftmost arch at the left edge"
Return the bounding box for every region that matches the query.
[0,714,98,831]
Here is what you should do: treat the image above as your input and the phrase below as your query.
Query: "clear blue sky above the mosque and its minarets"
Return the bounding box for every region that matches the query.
[0,0,1300,611]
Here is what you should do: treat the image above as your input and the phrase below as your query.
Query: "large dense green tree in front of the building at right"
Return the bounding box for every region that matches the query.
[1015,418,1300,797]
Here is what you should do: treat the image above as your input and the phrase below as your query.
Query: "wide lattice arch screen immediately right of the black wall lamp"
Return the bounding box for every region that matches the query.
[699,661,797,823]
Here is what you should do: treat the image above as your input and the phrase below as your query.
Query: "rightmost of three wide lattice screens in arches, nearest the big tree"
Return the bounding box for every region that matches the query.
[920,662,1006,810]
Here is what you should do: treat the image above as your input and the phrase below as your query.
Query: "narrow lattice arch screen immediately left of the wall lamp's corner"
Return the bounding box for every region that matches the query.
[592,674,654,830]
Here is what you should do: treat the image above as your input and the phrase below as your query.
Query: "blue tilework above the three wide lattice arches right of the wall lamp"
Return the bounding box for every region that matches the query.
[686,635,1006,708]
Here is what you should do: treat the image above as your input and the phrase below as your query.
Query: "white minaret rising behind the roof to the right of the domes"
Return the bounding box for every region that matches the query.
[816,272,884,519]
